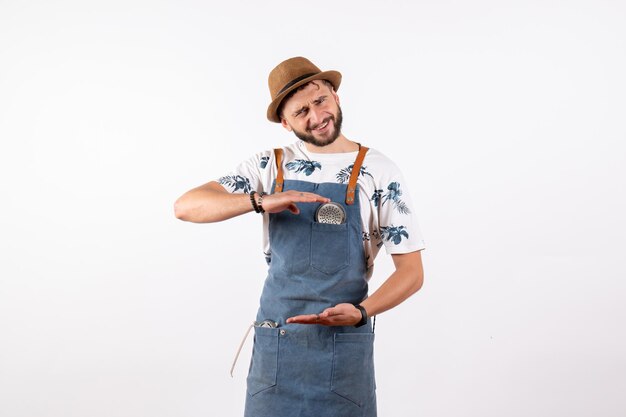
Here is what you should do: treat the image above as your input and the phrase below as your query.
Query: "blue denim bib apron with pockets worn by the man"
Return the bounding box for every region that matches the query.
[245,147,376,417]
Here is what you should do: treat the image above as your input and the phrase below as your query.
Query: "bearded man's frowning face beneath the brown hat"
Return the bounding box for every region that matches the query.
[281,80,343,147]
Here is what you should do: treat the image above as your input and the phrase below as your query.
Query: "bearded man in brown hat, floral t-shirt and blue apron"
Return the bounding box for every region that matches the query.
[175,57,424,417]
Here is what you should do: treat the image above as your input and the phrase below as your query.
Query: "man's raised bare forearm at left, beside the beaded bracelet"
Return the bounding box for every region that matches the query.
[174,182,253,223]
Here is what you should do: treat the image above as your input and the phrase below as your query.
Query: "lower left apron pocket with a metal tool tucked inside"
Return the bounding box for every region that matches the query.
[247,327,278,395]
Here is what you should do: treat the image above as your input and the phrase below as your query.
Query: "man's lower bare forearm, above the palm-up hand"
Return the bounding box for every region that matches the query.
[361,252,424,316]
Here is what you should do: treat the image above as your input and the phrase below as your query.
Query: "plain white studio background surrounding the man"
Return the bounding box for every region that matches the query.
[0,0,626,417]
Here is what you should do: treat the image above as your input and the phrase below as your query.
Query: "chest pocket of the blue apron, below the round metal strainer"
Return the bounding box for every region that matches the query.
[311,222,350,275]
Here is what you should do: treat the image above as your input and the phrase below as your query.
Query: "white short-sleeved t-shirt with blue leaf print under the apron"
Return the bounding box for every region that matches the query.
[217,140,424,279]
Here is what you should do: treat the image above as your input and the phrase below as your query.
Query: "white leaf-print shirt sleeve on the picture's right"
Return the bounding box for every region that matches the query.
[376,161,425,254]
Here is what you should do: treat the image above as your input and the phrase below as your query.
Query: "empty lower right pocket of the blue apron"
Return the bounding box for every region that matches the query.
[330,333,376,407]
